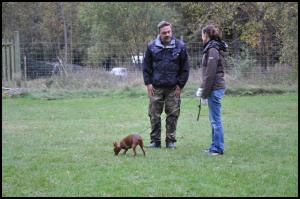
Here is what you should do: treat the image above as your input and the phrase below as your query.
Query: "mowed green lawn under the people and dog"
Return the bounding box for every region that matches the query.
[2,93,298,196]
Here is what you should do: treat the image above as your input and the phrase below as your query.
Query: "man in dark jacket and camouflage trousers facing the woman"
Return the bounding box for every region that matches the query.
[143,21,189,149]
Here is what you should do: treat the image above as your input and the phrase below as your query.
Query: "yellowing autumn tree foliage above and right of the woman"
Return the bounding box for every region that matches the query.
[174,2,298,70]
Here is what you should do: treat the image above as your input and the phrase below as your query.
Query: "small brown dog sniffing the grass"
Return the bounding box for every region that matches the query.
[113,134,146,156]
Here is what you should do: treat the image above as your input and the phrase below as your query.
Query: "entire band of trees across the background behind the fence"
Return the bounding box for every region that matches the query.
[2,2,298,69]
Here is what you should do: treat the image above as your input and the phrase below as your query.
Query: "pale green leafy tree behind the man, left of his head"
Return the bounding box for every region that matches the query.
[80,2,179,69]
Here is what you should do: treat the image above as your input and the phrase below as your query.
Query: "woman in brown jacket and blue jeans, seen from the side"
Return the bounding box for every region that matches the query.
[196,25,228,155]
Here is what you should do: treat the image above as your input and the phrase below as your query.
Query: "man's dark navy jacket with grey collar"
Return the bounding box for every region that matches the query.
[143,36,190,88]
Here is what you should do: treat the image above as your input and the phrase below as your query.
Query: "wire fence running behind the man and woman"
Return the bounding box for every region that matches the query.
[17,42,298,81]
